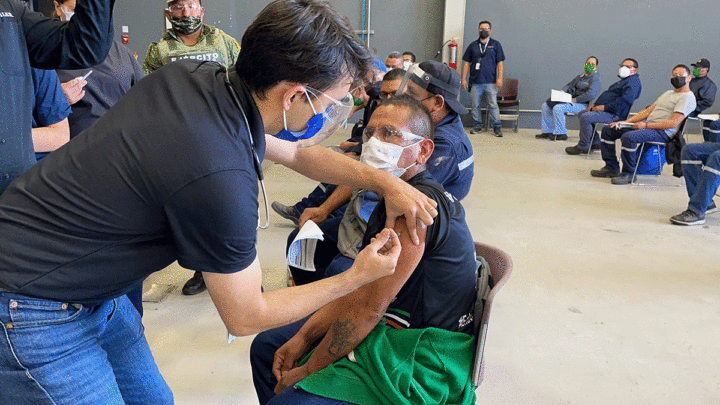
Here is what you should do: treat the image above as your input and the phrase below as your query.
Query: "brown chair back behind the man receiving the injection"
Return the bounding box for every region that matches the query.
[471,242,513,388]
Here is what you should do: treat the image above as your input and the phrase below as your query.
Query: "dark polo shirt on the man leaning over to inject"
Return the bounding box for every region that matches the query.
[0,61,265,305]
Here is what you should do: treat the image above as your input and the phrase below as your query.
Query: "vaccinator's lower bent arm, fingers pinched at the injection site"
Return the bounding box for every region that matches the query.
[203,229,400,336]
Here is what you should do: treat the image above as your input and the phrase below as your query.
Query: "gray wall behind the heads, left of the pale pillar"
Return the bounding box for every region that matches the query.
[115,0,444,68]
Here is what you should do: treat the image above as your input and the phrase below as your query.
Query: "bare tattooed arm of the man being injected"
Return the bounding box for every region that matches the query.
[273,219,426,393]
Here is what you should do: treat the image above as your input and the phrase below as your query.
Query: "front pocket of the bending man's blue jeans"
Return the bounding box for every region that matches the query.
[8,298,83,329]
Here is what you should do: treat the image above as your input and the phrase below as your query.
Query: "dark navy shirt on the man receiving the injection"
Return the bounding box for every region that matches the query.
[363,171,477,334]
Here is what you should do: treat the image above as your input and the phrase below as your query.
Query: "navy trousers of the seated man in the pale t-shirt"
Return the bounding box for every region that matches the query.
[600,127,670,174]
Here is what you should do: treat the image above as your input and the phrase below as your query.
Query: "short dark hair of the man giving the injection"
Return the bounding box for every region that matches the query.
[235,0,372,98]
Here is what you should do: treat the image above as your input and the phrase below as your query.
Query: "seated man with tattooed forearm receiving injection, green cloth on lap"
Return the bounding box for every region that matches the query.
[250,96,477,404]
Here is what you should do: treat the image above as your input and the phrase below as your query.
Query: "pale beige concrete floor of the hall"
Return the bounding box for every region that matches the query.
[144,130,720,404]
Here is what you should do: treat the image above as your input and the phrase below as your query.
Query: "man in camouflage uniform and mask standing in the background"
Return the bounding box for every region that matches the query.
[143,0,240,74]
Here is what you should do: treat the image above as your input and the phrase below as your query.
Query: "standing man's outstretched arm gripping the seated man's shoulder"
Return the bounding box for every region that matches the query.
[265,135,437,244]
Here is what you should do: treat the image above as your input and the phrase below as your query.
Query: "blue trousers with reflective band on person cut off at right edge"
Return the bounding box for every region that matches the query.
[681,142,720,215]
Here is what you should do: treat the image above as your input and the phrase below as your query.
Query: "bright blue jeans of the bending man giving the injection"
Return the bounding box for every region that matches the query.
[0,291,173,405]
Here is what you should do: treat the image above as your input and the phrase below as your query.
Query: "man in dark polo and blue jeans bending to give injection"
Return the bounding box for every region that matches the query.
[0,0,436,404]
